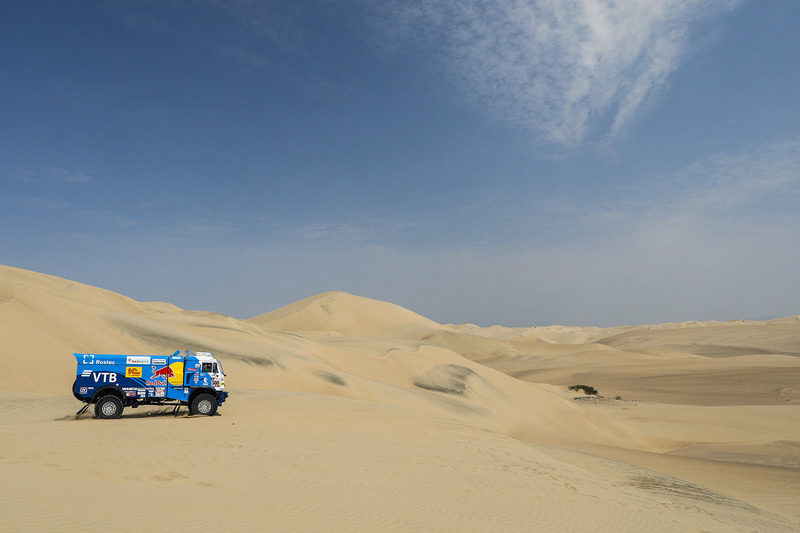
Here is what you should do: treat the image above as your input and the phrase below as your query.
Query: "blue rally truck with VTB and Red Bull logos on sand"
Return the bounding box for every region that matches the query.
[72,350,228,418]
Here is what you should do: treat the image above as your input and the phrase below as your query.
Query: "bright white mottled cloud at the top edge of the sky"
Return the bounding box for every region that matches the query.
[368,0,733,147]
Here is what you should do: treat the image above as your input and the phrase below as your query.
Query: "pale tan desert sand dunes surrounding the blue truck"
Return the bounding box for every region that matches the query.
[0,266,800,532]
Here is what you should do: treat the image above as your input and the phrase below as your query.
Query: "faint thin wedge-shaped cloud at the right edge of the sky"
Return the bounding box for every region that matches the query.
[576,138,800,233]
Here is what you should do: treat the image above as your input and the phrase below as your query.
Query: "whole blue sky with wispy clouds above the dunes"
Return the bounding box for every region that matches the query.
[0,0,800,326]
